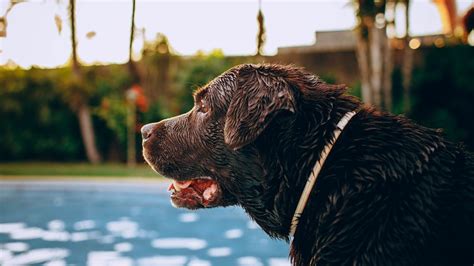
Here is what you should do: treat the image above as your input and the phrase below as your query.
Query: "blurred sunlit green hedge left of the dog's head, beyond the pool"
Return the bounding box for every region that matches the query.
[0,50,237,161]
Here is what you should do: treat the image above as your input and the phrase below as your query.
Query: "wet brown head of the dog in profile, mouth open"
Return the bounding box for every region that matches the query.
[142,65,348,215]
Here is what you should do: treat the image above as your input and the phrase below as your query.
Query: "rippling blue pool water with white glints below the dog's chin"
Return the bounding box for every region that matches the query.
[0,181,289,266]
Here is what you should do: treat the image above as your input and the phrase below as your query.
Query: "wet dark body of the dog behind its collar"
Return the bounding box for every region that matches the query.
[293,109,474,265]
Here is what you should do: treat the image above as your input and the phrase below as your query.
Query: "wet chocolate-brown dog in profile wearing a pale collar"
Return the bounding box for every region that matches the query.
[141,64,474,265]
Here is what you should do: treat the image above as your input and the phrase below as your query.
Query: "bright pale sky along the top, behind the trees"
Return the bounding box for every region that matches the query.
[0,0,472,68]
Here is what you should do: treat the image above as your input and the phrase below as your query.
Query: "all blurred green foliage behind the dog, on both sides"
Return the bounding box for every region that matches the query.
[0,45,474,161]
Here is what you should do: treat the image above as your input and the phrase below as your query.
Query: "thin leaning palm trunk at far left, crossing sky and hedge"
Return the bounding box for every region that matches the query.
[69,0,101,164]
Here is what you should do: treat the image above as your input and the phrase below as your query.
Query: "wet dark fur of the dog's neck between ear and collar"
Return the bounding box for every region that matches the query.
[243,92,359,240]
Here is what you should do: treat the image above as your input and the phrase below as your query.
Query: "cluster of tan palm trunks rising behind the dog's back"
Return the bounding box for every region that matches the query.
[354,0,413,111]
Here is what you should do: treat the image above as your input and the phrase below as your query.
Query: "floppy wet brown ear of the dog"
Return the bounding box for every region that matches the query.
[224,65,295,150]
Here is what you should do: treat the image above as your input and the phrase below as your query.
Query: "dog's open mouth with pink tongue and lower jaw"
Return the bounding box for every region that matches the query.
[168,177,222,209]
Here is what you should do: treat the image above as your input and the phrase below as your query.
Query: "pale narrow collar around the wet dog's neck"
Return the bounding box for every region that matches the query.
[290,111,357,237]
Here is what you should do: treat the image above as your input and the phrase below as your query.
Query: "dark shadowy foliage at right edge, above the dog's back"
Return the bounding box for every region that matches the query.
[409,46,474,151]
